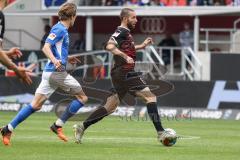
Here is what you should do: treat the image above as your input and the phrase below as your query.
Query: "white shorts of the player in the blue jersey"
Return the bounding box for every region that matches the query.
[36,72,82,98]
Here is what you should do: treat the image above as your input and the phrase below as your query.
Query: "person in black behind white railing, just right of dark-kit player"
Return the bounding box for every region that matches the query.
[158,32,177,65]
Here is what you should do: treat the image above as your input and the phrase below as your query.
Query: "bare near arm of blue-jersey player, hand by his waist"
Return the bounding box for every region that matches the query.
[42,43,62,70]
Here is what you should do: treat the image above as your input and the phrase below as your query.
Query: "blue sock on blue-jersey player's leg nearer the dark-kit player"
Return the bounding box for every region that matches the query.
[56,100,84,126]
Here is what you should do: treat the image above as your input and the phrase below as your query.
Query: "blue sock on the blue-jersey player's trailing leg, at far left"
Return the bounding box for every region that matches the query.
[8,104,35,131]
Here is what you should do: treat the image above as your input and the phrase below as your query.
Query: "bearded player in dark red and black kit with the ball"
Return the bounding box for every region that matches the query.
[74,8,172,143]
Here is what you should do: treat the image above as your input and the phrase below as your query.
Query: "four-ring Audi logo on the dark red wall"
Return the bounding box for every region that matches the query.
[140,17,166,34]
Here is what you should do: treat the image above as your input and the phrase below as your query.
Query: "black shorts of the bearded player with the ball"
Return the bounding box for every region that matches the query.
[111,67,147,100]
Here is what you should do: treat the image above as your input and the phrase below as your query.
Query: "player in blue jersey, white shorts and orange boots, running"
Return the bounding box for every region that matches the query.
[1,3,88,145]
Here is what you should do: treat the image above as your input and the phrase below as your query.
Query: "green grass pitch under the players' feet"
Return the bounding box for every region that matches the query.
[0,111,240,160]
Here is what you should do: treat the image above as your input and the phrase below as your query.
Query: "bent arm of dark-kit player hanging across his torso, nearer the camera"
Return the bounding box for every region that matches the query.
[106,39,134,63]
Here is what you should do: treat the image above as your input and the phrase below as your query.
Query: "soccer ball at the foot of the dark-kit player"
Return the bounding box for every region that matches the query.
[160,128,177,147]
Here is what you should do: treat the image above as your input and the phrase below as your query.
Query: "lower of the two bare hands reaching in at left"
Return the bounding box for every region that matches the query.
[14,66,32,85]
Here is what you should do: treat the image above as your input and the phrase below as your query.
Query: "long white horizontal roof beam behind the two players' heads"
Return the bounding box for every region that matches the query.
[5,6,240,16]
